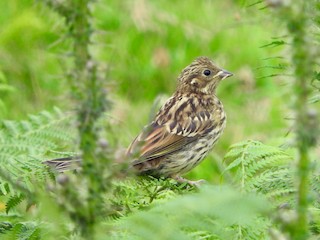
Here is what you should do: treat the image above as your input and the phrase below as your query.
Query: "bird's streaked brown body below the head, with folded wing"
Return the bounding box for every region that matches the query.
[131,93,226,177]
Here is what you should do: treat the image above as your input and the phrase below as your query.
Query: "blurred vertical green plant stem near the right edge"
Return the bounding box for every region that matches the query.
[288,0,313,239]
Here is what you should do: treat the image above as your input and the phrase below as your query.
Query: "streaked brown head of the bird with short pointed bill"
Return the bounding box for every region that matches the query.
[177,57,233,94]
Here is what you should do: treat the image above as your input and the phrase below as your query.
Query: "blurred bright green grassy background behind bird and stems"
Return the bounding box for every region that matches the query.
[0,0,290,182]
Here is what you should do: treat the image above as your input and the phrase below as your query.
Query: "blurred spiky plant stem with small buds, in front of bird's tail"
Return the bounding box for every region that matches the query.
[46,0,107,239]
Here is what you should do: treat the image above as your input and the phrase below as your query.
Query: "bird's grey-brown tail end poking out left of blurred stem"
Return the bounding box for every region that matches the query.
[43,156,82,172]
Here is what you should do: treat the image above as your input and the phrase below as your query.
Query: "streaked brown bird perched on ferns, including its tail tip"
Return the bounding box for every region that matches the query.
[45,56,233,186]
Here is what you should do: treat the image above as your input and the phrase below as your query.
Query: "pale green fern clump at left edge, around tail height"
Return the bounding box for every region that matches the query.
[0,109,73,211]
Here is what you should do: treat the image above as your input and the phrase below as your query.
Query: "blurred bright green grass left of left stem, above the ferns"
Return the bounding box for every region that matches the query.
[0,0,67,119]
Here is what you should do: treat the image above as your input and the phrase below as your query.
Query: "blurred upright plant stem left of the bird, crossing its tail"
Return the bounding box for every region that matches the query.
[71,0,105,239]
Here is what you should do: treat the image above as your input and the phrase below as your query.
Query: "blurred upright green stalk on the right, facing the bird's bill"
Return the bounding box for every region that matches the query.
[270,0,316,240]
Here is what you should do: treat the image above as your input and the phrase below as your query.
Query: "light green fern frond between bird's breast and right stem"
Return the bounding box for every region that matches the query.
[224,140,294,200]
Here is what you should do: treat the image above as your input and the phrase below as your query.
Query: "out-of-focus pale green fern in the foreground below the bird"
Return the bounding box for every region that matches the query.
[114,186,270,239]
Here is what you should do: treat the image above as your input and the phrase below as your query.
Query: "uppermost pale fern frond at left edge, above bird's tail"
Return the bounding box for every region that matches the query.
[0,110,73,153]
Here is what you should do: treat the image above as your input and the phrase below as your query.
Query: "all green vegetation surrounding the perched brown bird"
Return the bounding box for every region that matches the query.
[0,0,320,239]
